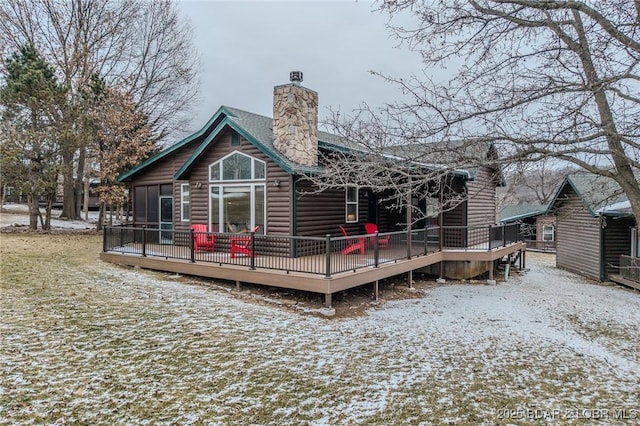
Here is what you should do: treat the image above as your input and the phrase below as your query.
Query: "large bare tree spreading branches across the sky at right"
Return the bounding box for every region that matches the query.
[318,0,640,223]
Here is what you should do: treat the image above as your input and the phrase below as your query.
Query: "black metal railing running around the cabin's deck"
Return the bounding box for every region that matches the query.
[103,224,519,277]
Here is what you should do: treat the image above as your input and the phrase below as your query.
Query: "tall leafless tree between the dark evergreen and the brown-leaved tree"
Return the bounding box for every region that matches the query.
[0,0,199,218]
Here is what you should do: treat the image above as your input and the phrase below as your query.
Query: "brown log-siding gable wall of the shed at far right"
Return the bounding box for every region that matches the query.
[556,191,600,280]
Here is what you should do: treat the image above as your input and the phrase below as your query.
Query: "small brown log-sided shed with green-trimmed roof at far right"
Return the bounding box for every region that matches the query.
[547,173,636,281]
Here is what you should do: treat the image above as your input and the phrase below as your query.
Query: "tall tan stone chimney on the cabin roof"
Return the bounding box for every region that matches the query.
[273,71,318,166]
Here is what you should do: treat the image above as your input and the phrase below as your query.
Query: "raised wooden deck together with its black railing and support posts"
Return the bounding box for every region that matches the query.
[100,224,526,306]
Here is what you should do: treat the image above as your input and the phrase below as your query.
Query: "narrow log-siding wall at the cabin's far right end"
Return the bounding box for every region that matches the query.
[467,167,496,226]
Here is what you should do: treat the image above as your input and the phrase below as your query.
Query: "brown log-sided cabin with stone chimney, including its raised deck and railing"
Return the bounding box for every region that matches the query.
[102,71,522,304]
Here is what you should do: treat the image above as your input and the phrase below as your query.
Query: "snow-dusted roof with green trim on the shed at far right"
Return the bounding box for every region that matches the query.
[550,172,630,216]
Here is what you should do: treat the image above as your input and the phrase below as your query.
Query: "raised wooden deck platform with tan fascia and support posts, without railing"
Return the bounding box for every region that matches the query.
[100,242,526,306]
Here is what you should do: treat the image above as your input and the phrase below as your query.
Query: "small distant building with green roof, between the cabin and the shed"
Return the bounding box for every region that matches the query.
[499,204,556,252]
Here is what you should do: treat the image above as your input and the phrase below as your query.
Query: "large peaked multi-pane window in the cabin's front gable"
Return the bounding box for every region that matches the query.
[209,151,267,233]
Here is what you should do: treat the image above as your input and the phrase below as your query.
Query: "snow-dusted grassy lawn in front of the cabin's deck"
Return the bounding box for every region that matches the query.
[0,230,640,425]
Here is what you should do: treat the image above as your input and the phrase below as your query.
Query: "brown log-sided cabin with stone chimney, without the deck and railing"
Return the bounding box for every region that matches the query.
[119,72,497,246]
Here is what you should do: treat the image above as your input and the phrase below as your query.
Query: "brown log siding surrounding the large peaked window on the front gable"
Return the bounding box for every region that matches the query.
[178,130,292,235]
